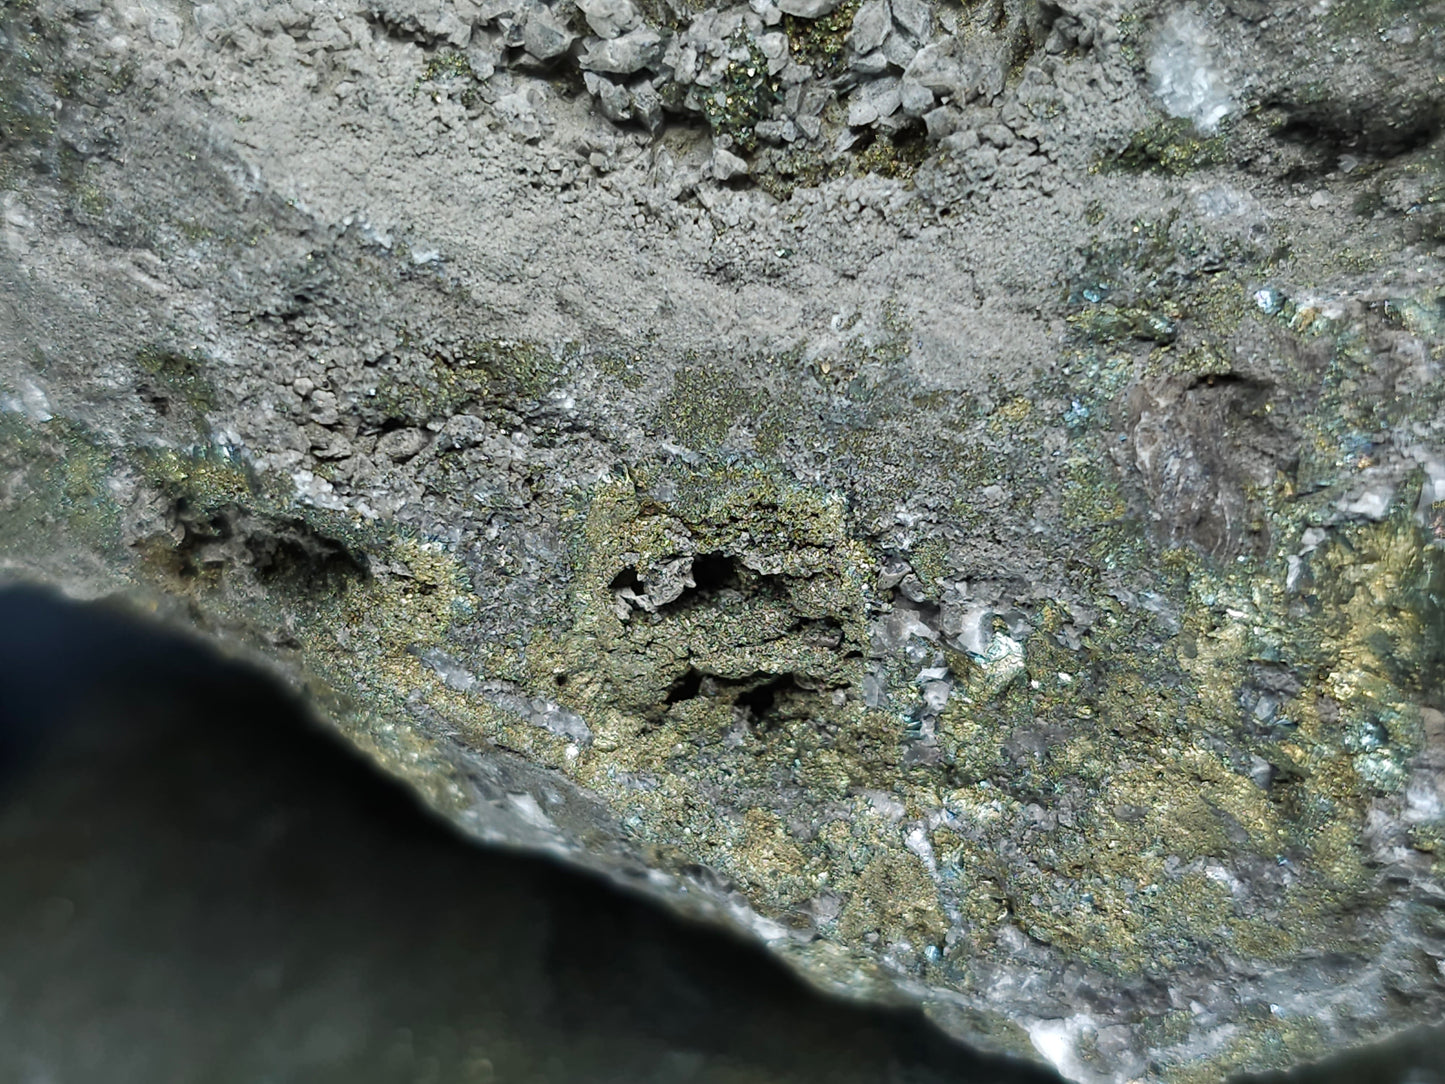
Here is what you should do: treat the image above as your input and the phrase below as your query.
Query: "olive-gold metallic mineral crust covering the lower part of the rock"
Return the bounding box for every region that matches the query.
[4,280,1445,1067]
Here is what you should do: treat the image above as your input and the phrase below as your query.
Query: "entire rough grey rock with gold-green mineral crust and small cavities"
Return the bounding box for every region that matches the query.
[0,0,1445,1081]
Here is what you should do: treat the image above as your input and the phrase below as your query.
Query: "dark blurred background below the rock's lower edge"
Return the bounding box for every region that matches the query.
[0,588,1445,1084]
